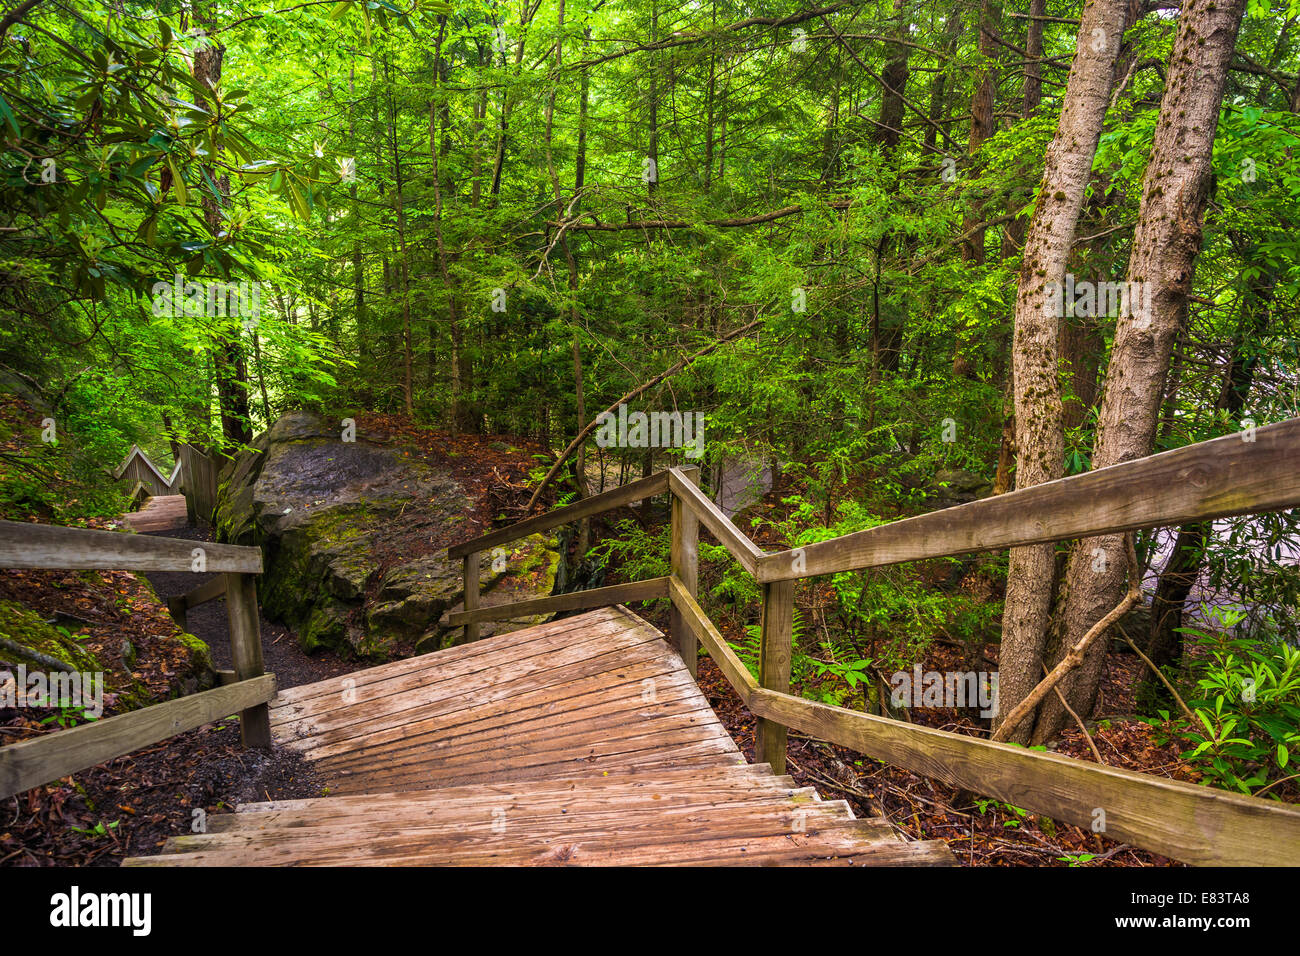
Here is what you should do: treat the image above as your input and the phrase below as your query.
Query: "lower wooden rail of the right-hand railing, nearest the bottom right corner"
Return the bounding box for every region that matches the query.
[750,688,1300,866]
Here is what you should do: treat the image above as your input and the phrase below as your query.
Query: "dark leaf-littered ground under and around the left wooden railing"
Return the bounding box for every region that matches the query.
[0,528,351,866]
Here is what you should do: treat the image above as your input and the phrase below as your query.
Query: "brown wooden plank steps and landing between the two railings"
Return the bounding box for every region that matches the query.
[126,607,953,866]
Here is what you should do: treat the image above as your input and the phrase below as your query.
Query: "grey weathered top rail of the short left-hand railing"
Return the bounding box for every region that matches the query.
[0,522,261,574]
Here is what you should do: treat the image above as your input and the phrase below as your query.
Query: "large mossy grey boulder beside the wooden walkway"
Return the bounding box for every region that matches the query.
[216,412,559,659]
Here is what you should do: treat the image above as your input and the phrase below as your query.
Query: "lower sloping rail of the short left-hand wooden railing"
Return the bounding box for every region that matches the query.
[0,674,276,799]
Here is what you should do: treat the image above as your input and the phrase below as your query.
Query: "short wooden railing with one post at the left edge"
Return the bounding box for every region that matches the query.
[0,522,276,799]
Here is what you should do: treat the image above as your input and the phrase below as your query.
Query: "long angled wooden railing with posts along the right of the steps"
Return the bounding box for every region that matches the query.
[447,419,1300,865]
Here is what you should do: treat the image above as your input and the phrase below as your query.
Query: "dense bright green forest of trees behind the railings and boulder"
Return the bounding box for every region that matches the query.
[0,0,1300,868]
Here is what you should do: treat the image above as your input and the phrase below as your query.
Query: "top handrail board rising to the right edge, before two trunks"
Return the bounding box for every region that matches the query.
[755,419,1300,581]
